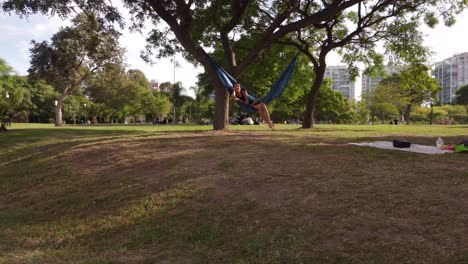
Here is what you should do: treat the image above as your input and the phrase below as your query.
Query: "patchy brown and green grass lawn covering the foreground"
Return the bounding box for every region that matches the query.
[0,124,468,263]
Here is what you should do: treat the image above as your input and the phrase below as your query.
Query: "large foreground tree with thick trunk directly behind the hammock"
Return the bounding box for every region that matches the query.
[3,0,374,129]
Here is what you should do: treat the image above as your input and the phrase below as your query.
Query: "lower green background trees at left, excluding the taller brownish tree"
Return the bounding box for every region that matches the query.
[0,58,218,127]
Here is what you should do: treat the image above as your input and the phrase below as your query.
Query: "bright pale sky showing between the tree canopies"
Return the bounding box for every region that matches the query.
[0,7,468,98]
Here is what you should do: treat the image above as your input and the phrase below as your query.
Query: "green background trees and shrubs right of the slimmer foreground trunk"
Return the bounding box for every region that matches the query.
[310,64,468,124]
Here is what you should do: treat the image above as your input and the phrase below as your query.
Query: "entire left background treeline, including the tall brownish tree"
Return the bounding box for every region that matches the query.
[0,13,217,130]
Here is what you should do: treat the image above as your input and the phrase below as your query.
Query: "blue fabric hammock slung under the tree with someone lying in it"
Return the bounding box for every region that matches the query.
[208,56,297,113]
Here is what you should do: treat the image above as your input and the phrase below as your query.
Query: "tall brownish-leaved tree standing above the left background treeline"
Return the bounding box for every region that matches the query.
[28,13,122,126]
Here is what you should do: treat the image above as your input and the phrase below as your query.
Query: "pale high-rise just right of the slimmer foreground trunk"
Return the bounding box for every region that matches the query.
[325,66,356,99]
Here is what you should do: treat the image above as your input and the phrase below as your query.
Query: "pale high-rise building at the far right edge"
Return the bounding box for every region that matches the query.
[432,52,468,104]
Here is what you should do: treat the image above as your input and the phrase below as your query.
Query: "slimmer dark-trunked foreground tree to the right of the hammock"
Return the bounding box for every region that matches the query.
[278,0,467,128]
